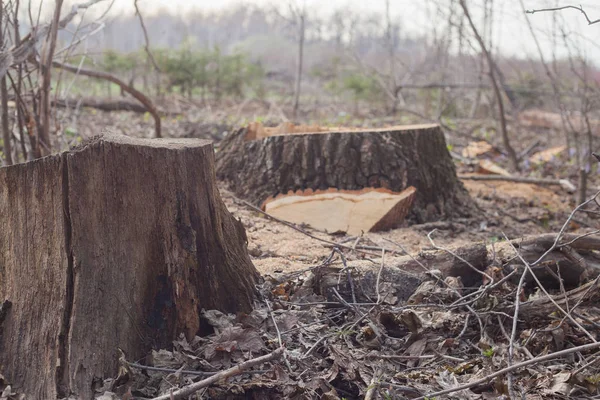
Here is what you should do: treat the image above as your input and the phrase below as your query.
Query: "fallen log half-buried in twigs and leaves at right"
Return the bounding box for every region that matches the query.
[304,234,600,304]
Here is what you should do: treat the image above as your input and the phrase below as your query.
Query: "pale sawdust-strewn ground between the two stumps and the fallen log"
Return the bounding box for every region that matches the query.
[221,181,572,275]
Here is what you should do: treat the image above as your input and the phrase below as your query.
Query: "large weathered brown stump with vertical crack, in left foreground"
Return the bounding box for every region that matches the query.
[0,136,259,399]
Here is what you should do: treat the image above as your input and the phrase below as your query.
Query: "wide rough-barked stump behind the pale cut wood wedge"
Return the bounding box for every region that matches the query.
[217,125,474,222]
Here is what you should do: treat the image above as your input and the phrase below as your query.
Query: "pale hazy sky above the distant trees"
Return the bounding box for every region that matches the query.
[52,0,600,66]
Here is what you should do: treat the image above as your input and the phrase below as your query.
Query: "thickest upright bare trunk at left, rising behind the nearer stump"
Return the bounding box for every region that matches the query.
[39,0,63,154]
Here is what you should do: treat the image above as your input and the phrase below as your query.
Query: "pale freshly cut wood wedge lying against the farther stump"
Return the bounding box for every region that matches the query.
[262,186,416,235]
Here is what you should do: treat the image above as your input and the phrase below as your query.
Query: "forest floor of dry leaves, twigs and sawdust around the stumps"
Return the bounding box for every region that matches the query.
[45,101,600,400]
